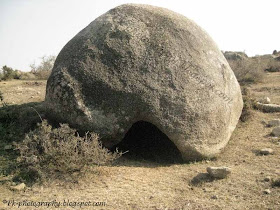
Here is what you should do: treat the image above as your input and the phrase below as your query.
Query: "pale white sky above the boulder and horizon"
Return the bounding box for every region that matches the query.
[0,0,280,71]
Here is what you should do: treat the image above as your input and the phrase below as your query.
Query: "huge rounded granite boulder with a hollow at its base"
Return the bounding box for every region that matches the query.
[46,4,243,160]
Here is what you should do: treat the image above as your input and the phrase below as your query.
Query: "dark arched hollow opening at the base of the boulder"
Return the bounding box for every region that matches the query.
[113,121,183,164]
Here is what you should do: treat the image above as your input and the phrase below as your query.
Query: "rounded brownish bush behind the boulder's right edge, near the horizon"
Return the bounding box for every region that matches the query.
[228,58,265,84]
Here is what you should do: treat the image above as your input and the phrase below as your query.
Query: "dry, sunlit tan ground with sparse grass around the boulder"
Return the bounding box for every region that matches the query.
[0,73,280,210]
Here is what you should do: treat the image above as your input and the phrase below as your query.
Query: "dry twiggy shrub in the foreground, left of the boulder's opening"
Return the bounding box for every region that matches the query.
[16,120,122,181]
